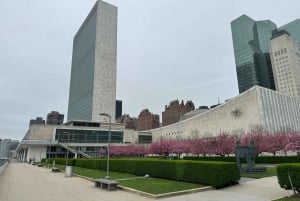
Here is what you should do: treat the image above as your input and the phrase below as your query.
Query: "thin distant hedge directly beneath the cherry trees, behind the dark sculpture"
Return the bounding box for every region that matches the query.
[184,156,300,164]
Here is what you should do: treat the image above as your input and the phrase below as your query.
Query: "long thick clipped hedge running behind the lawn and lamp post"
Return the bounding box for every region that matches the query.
[70,159,240,188]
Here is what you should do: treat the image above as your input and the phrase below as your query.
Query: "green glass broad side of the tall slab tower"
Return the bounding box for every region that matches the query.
[68,5,97,120]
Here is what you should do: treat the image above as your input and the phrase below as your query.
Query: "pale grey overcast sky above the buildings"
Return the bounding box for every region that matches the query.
[0,0,300,140]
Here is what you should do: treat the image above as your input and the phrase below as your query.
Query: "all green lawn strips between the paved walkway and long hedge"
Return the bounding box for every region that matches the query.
[43,163,203,194]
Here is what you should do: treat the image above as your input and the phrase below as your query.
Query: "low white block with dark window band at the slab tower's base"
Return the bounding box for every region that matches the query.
[16,121,132,162]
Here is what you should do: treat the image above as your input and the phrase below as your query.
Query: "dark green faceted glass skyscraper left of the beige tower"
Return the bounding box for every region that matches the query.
[231,15,276,93]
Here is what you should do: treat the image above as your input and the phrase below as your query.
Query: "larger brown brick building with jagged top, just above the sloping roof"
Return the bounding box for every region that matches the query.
[162,100,195,126]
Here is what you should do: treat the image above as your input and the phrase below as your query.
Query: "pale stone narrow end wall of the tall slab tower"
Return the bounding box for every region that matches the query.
[92,0,118,123]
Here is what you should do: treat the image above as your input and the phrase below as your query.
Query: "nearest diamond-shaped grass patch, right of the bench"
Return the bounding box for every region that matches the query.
[119,178,203,194]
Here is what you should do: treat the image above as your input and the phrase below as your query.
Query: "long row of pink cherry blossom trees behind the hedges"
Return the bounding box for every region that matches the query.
[103,129,300,158]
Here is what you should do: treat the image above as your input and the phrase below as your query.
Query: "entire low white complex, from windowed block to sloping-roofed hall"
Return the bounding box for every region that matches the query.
[17,86,300,162]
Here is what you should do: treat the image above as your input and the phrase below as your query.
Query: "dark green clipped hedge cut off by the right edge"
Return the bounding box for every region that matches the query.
[277,163,300,193]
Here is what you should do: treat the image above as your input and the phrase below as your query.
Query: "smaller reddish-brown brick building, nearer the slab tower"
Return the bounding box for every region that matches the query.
[135,109,159,131]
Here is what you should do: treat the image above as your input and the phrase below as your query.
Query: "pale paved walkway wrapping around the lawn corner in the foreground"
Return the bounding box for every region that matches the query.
[0,163,292,201]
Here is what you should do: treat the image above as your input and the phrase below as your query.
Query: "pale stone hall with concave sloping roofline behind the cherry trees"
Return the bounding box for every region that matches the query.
[147,86,300,141]
